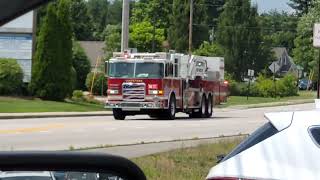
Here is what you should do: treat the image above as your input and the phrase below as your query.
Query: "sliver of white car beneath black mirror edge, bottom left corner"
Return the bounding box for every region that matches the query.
[0,171,55,180]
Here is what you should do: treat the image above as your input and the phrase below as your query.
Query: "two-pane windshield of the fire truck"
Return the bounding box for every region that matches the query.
[109,62,164,78]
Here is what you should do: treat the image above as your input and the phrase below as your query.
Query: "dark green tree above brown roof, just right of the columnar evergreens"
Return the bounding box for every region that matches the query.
[70,0,94,41]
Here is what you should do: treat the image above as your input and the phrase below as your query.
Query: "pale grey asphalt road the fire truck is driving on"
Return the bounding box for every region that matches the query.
[0,104,314,151]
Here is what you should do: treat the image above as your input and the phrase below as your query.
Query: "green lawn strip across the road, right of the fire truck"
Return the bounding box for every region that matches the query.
[218,91,316,107]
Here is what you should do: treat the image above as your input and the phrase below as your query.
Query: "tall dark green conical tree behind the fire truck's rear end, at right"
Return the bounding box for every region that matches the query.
[217,0,270,81]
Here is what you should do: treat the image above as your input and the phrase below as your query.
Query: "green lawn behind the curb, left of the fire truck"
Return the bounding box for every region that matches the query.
[0,97,104,113]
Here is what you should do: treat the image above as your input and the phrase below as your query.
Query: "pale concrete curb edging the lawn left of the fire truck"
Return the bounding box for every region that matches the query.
[0,111,112,120]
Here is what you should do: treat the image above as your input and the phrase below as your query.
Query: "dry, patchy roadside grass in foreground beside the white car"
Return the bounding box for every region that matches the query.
[133,139,241,180]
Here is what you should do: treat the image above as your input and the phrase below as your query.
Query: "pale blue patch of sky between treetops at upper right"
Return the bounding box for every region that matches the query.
[252,0,293,13]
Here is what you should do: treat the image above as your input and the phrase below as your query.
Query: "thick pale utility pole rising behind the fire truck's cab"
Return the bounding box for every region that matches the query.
[121,0,130,52]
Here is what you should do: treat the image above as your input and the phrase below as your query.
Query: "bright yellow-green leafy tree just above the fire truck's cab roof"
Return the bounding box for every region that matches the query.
[130,21,165,52]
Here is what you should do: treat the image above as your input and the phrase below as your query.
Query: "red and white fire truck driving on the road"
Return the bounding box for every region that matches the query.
[105,53,228,120]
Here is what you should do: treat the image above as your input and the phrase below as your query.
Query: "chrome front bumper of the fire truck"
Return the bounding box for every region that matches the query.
[105,101,165,111]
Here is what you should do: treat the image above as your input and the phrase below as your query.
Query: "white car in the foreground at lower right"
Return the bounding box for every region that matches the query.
[207,102,320,180]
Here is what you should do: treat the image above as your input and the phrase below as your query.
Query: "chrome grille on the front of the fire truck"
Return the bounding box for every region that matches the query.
[122,83,146,101]
